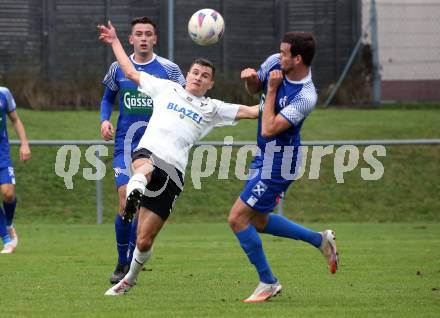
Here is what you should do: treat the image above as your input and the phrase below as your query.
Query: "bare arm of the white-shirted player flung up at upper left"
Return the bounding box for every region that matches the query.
[98,21,140,85]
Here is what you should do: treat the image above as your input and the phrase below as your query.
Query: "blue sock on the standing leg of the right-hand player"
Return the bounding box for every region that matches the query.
[235,225,277,284]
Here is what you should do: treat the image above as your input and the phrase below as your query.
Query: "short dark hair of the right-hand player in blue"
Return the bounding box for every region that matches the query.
[282,32,315,66]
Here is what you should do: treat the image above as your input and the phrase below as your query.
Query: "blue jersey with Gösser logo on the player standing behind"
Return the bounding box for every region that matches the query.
[103,54,185,155]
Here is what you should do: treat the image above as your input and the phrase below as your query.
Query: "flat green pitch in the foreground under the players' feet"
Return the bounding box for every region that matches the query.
[0,223,440,318]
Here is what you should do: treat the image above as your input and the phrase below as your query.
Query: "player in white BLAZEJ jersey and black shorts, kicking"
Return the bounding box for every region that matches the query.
[98,22,258,296]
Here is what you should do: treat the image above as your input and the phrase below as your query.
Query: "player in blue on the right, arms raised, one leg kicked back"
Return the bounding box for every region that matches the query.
[228,32,338,302]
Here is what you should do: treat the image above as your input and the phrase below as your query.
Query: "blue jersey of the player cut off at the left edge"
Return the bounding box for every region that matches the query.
[0,86,16,168]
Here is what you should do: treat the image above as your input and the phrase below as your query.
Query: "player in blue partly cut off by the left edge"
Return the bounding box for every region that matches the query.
[0,87,31,254]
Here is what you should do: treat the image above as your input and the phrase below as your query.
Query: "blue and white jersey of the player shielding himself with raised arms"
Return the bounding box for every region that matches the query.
[254,54,317,170]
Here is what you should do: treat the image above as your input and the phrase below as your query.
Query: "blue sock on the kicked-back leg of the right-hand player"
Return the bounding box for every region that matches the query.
[263,213,322,247]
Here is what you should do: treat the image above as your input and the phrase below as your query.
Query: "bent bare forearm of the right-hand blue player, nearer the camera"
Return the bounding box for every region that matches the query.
[261,70,291,137]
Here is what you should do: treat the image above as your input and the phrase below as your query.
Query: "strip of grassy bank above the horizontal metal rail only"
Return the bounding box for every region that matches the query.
[10,108,440,140]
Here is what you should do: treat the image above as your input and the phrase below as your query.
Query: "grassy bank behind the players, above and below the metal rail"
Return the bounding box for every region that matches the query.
[6,109,440,223]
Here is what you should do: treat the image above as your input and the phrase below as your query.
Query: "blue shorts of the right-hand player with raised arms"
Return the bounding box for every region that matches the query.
[240,167,293,213]
